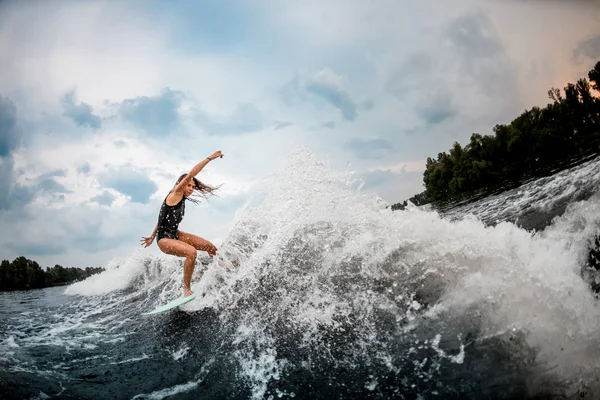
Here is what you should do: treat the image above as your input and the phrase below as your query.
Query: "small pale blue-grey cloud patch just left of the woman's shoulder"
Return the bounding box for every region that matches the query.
[98,165,158,204]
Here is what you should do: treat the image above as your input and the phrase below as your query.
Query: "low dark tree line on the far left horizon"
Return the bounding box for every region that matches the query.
[0,257,103,291]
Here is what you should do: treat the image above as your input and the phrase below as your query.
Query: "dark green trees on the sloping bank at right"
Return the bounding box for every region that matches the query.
[392,61,600,209]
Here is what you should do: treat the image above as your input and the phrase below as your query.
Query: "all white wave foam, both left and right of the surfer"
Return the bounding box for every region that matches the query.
[32,149,600,399]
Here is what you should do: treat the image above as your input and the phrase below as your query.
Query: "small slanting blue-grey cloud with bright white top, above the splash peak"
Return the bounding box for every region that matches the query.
[306,68,358,121]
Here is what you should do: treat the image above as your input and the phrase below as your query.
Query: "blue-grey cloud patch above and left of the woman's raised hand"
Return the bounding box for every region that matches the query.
[118,88,185,135]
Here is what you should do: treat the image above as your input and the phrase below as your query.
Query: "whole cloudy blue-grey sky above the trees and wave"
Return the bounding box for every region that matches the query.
[0,0,600,267]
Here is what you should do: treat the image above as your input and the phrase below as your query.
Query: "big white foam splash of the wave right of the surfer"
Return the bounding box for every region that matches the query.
[192,151,600,397]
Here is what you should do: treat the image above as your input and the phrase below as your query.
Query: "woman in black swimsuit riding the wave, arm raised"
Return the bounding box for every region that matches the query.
[141,150,223,297]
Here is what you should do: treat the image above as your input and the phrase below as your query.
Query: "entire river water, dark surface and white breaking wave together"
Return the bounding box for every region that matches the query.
[0,150,600,399]
